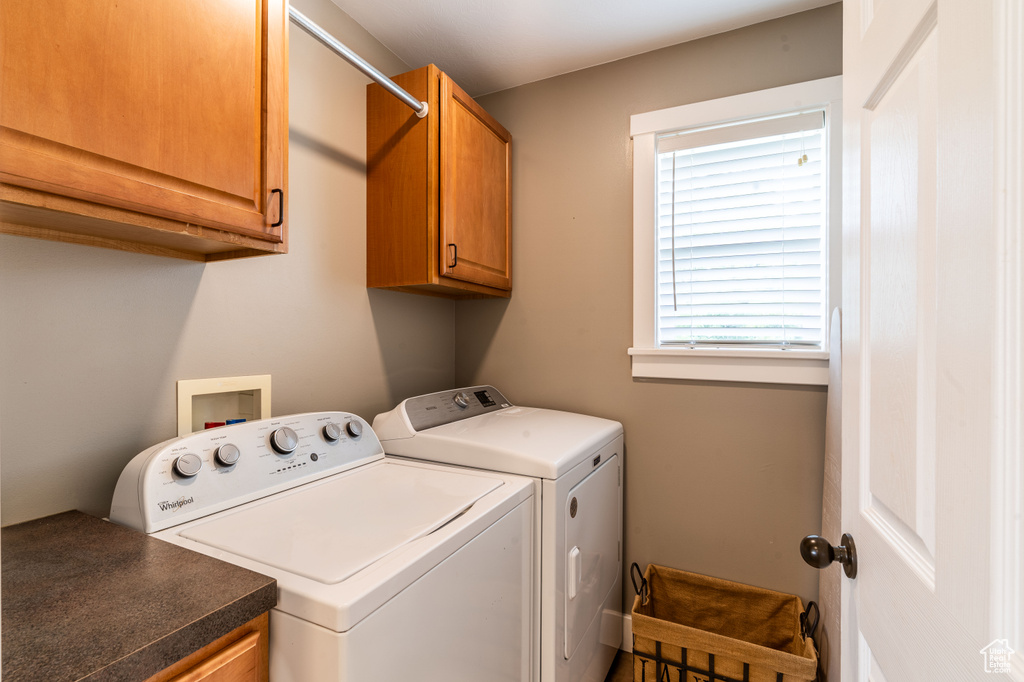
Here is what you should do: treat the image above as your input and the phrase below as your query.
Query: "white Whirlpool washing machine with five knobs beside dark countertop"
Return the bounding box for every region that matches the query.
[111,412,536,682]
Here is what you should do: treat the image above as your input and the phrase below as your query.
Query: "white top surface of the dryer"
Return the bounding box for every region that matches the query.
[375,407,623,479]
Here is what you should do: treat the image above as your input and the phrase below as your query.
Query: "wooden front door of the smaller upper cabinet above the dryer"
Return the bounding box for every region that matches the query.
[439,74,512,290]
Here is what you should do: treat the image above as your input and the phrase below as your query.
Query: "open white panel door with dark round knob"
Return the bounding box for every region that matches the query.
[843,0,1024,682]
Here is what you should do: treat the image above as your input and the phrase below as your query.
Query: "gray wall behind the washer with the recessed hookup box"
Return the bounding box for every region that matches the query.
[0,0,455,525]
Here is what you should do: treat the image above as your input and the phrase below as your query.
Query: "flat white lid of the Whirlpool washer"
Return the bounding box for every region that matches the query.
[180,461,503,585]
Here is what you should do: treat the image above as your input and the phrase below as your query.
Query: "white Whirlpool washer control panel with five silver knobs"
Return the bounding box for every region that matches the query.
[111,412,384,532]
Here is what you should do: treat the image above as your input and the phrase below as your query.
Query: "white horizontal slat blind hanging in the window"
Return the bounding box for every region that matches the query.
[656,110,827,349]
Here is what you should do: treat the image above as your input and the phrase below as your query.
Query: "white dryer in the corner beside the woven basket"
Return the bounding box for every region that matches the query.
[374,386,623,682]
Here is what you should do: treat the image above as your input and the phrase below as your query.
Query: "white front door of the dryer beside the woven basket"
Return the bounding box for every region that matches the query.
[563,457,622,658]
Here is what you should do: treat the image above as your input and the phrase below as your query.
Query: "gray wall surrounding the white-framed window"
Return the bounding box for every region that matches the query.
[456,4,842,604]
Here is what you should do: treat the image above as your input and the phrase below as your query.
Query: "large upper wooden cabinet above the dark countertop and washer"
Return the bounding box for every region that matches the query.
[0,0,288,260]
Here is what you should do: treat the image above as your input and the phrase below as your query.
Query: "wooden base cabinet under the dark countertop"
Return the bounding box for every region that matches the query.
[146,613,270,682]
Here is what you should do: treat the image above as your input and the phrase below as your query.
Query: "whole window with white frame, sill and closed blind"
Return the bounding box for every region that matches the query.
[629,76,843,384]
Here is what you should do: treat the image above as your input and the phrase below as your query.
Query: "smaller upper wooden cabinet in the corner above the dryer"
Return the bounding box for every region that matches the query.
[367,65,512,298]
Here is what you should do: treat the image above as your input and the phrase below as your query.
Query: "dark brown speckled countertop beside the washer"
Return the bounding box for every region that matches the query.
[0,511,278,682]
